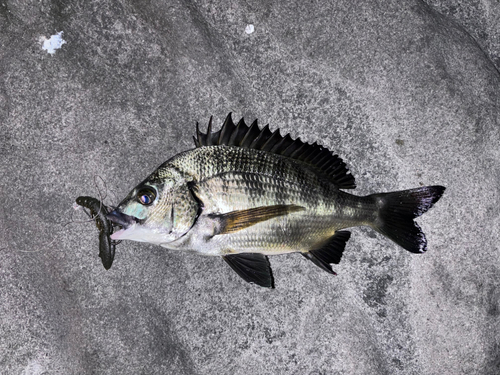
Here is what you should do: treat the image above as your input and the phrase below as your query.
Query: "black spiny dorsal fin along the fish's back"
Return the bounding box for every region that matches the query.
[193,113,356,189]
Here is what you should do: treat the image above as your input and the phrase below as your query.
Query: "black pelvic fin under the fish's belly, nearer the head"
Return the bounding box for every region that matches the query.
[222,253,274,288]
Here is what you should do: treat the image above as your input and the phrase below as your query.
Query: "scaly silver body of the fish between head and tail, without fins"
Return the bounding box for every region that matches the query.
[153,146,372,255]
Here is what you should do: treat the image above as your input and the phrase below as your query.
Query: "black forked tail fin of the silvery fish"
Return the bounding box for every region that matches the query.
[369,186,445,253]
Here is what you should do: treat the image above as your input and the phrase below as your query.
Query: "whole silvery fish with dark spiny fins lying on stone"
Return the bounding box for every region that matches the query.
[107,113,445,288]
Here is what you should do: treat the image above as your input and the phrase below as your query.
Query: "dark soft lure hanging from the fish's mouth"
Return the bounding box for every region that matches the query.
[76,196,116,270]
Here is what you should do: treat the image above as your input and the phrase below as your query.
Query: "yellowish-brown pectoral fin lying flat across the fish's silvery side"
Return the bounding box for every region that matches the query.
[212,204,305,234]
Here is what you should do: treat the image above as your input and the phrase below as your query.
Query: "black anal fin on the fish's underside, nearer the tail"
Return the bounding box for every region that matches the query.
[302,231,351,275]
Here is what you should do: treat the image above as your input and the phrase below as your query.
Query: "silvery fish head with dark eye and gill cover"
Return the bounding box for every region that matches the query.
[107,167,200,244]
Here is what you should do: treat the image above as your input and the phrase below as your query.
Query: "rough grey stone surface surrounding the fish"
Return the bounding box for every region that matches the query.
[0,0,500,374]
